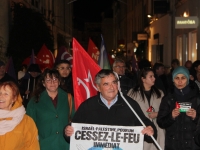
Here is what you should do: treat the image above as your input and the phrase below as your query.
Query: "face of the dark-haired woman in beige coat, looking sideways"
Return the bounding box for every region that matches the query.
[142,71,155,90]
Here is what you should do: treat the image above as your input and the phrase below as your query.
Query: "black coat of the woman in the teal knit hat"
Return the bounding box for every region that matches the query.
[157,82,200,150]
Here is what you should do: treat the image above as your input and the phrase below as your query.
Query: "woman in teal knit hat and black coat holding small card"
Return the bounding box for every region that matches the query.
[157,66,200,150]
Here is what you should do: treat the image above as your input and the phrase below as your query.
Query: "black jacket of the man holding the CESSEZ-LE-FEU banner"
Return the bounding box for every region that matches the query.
[66,94,157,142]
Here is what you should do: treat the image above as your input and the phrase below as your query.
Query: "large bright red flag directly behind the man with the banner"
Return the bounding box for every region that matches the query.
[72,38,100,109]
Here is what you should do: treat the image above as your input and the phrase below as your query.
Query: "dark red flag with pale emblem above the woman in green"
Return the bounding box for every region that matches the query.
[37,44,55,70]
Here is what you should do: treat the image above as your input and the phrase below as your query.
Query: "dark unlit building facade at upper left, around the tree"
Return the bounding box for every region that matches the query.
[0,0,73,54]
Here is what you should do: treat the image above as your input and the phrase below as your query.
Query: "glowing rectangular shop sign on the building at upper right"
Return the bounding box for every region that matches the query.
[175,16,199,29]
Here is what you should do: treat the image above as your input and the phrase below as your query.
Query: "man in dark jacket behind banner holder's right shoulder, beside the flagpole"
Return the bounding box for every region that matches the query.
[113,59,137,95]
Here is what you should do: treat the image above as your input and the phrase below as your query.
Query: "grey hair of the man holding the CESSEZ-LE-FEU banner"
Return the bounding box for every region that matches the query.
[95,69,118,85]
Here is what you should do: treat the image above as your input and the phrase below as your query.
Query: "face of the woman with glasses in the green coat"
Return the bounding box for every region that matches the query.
[43,74,60,92]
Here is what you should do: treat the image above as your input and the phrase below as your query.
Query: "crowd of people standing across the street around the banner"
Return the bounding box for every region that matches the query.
[0,59,200,150]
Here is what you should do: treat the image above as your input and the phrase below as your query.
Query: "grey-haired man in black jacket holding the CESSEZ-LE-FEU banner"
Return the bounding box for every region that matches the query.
[64,69,157,148]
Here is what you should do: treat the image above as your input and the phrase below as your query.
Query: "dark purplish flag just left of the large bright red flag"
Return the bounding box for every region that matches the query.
[56,46,73,66]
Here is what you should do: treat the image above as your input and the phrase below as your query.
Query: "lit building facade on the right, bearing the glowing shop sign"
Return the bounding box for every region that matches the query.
[113,0,200,66]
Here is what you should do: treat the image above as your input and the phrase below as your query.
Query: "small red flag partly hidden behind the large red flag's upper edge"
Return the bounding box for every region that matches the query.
[88,39,100,63]
